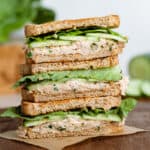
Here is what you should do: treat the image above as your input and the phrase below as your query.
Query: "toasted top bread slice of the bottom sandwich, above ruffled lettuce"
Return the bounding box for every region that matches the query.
[21,96,121,116]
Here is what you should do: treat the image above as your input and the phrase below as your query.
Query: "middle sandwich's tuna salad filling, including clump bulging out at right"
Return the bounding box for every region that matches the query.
[26,77,128,95]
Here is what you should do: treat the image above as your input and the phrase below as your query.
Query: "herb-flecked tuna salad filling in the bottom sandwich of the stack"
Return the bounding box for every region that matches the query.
[19,117,124,135]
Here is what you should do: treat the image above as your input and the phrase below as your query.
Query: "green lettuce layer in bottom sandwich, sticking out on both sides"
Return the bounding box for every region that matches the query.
[0,98,136,126]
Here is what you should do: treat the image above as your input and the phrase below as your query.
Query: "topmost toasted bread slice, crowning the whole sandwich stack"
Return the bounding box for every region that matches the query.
[25,15,120,37]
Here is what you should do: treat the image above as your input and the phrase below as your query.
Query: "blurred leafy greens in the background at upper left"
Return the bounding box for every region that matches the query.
[0,0,55,43]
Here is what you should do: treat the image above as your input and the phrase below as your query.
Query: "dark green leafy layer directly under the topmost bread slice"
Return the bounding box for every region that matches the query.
[26,27,128,47]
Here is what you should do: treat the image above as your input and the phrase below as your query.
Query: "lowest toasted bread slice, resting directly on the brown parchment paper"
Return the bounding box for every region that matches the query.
[18,121,124,139]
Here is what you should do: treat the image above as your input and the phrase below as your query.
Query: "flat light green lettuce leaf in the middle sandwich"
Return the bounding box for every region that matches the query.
[14,66,122,87]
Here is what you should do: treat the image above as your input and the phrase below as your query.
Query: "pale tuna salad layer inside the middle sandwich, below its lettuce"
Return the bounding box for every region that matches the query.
[27,79,119,94]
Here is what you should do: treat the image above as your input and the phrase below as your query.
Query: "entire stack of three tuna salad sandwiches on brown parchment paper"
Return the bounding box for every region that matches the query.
[1,15,136,138]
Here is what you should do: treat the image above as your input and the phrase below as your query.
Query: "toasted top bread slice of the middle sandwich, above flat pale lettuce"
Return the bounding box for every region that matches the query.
[21,55,119,75]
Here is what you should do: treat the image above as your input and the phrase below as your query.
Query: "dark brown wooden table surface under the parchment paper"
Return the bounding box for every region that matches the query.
[0,100,150,150]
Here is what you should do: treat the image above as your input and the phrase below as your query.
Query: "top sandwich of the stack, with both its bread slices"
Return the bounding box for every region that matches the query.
[25,15,127,64]
